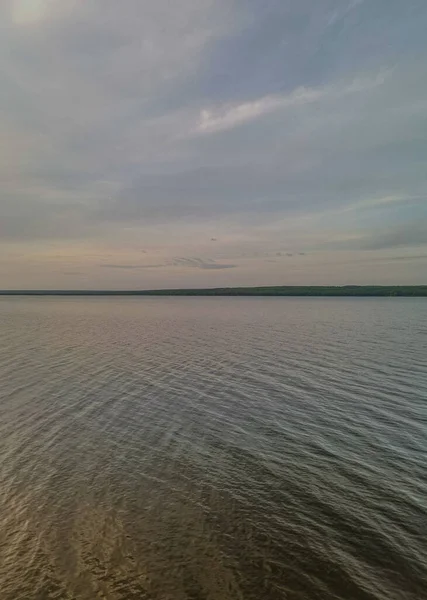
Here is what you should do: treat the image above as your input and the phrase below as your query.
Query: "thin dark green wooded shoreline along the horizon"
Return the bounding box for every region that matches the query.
[0,285,427,297]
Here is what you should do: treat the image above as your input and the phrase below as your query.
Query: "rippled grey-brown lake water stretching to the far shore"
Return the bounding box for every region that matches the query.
[0,297,427,600]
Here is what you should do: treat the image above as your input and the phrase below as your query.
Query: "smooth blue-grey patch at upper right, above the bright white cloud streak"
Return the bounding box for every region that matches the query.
[181,0,426,108]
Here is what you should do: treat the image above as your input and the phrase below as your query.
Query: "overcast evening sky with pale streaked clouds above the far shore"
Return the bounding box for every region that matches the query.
[0,0,427,289]
